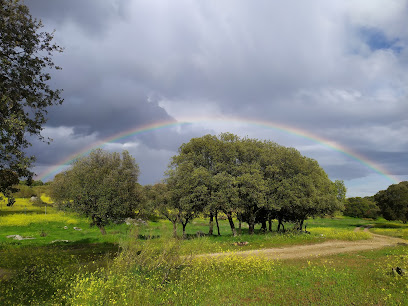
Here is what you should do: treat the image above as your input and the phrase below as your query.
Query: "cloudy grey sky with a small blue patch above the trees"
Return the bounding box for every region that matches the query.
[25,0,408,197]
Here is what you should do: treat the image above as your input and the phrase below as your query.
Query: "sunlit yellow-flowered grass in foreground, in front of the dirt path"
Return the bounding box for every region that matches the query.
[65,240,408,305]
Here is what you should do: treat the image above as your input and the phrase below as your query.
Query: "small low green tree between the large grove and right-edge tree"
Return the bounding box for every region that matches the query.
[343,197,380,219]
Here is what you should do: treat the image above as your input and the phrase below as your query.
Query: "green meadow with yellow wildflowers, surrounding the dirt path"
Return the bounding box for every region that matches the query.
[0,197,408,305]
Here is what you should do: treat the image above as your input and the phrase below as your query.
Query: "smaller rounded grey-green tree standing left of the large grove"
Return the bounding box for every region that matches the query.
[51,149,140,234]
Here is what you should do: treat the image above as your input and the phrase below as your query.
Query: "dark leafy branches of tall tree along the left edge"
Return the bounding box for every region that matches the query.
[0,0,62,193]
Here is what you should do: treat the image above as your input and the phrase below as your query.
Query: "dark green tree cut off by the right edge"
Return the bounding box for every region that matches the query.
[374,181,408,223]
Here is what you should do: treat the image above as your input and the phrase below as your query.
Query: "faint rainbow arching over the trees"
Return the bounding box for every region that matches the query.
[36,117,400,183]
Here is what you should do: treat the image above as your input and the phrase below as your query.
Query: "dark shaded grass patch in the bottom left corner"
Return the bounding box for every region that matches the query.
[0,243,117,305]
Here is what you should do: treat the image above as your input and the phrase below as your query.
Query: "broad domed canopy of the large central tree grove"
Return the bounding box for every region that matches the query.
[166,133,345,235]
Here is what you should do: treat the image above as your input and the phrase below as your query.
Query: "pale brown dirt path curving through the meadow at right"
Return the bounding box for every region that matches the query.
[200,228,408,259]
